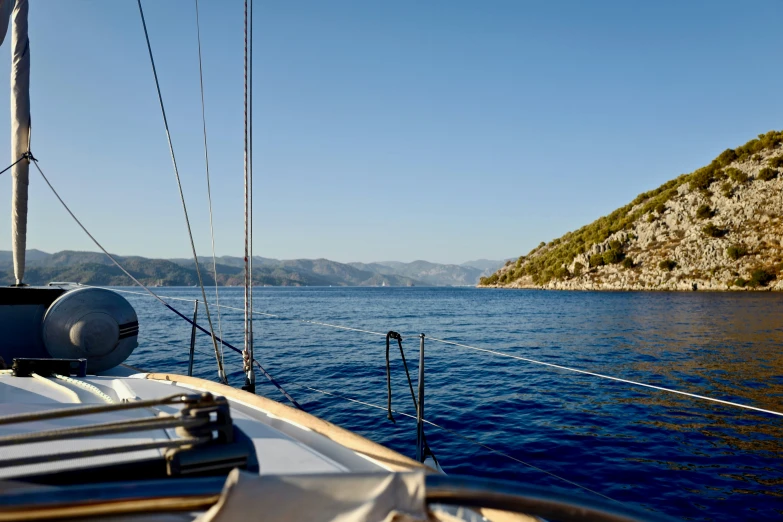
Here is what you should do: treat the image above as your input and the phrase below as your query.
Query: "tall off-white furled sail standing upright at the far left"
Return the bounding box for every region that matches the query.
[11,0,30,286]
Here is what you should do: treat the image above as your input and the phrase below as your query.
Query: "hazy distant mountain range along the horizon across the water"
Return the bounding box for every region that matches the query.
[0,250,504,286]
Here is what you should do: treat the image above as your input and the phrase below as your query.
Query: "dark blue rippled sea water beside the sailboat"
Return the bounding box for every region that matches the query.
[128,288,783,520]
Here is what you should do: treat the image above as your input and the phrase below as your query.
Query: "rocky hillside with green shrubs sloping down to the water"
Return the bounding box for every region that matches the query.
[479,131,783,290]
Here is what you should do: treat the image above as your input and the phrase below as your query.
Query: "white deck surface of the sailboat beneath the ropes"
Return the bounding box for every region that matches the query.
[0,372,387,479]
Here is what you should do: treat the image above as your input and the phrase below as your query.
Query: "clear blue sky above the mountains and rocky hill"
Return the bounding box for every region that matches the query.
[0,0,783,262]
